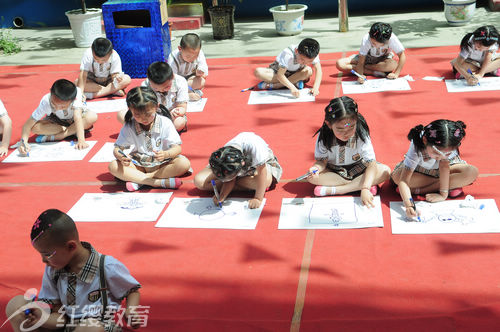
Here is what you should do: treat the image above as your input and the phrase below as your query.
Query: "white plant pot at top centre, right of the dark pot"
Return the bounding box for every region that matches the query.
[269,4,307,36]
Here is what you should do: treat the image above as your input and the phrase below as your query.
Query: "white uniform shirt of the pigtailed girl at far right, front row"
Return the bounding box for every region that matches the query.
[394,141,466,178]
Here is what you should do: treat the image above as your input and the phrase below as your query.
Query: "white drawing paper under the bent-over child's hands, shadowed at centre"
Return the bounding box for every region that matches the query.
[156,197,266,229]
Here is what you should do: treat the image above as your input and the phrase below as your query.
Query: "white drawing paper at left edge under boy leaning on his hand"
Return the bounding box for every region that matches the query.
[3,141,97,163]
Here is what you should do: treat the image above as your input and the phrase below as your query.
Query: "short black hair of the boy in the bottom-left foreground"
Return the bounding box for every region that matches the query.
[30,209,79,246]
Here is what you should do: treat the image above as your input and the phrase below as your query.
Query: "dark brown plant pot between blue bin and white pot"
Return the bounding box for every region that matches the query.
[207,0,237,39]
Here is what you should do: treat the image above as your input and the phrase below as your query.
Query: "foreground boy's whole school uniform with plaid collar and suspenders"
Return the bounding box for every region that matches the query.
[38,242,141,331]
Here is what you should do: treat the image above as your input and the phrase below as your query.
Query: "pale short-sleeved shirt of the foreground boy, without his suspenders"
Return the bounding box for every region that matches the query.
[38,242,140,318]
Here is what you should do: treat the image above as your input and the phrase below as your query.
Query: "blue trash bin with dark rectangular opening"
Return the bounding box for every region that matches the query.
[102,0,171,78]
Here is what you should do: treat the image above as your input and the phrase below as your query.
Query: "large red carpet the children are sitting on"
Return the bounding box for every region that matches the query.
[0,46,500,332]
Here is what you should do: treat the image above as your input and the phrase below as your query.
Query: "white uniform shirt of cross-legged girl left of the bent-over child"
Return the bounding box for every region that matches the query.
[115,114,182,169]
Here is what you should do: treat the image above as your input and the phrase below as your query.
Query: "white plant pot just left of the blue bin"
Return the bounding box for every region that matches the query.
[66,8,102,47]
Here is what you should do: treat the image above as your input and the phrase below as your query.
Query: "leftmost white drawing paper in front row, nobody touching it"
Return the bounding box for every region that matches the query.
[68,192,172,221]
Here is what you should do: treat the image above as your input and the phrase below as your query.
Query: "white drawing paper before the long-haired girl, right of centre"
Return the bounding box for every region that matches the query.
[278,196,384,229]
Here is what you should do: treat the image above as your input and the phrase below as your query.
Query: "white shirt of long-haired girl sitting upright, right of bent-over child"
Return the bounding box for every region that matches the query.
[314,135,375,166]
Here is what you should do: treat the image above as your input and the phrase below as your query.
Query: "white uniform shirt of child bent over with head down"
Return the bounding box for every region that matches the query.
[224,132,283,186]
